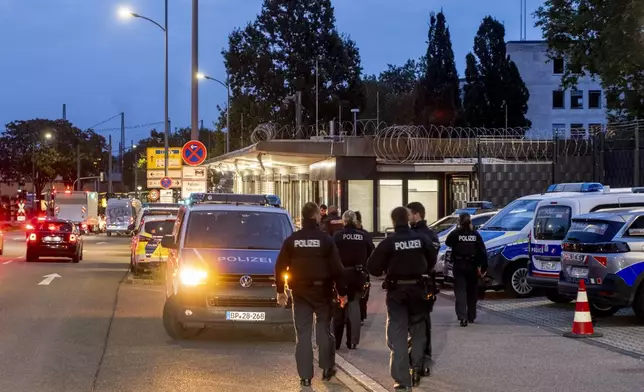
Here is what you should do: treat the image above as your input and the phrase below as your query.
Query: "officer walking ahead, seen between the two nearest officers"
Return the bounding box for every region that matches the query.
[333,210,374,350]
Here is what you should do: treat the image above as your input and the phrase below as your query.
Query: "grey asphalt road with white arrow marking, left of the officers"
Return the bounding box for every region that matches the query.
[0,232,363,392]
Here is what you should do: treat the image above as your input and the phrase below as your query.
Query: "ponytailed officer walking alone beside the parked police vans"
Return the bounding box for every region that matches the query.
[445,213,487,327]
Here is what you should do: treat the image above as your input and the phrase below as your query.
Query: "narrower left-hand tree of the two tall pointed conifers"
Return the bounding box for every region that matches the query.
[415,11,461,126]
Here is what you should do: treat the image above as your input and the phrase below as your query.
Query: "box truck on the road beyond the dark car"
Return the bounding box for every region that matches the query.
[54,190,99,234]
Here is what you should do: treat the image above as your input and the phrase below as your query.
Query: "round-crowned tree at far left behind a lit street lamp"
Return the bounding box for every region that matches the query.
[0,119,105,195]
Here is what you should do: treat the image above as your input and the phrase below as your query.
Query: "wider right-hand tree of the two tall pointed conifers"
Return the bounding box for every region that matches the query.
[464,16,530,128]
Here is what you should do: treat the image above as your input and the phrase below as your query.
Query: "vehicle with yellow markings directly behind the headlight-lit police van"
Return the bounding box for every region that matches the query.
[130,215,177,275]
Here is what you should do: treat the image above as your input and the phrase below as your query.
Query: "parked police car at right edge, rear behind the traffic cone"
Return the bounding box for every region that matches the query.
[558,208,644,323]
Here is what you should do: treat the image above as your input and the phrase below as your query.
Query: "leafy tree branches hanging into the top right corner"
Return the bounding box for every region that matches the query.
[535,0,644,118]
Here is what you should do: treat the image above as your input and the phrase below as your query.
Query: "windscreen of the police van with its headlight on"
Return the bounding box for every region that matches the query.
[185,211,293,250]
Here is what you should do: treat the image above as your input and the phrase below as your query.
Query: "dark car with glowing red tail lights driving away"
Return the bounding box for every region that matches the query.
[25,219,83,263]
